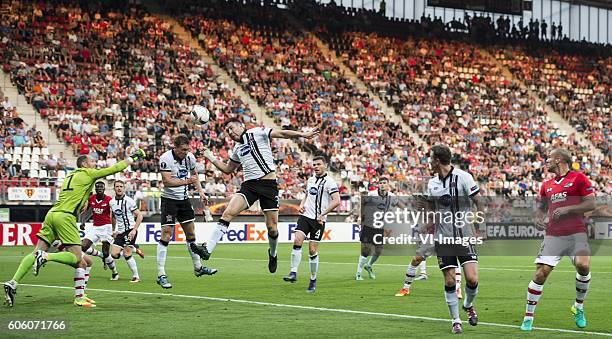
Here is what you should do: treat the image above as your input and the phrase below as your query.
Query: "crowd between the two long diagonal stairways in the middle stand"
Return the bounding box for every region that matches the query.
[182,1,425,191]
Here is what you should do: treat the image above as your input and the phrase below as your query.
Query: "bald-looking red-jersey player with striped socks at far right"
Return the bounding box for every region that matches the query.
[521,148,596,331]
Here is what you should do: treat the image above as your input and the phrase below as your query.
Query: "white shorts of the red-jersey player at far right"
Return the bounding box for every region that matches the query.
[534,233,591,267]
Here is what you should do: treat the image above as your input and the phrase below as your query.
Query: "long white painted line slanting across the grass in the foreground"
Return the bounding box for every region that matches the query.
[20,284,612,337]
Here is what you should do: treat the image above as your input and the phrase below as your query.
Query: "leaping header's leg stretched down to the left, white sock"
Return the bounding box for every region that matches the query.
[191,194,249,260]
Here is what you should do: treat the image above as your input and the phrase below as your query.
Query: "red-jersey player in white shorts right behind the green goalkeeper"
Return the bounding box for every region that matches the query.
[81,181,119,280]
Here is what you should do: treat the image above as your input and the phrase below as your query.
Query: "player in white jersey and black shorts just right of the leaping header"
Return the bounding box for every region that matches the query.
[283,156,340,293]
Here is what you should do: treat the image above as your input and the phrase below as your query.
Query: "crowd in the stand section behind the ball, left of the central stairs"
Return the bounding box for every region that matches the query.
[0,1,314,199]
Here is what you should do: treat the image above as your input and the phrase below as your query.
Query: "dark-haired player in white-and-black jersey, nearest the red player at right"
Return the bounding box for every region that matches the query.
[427,145,482,333]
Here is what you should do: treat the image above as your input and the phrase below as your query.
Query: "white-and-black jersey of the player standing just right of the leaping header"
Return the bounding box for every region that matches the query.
[302,173,338,219]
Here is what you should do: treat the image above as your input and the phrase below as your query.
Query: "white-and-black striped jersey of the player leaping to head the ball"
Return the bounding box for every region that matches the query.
[230,127,276,181]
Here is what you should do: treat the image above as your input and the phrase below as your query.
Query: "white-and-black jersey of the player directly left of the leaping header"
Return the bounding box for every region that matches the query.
[159,150,196,200]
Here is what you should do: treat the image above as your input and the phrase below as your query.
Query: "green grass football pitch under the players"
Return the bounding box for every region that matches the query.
[0,243,612,338]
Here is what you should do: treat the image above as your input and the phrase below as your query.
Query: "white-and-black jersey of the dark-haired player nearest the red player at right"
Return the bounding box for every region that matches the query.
[427,167,479,237]
